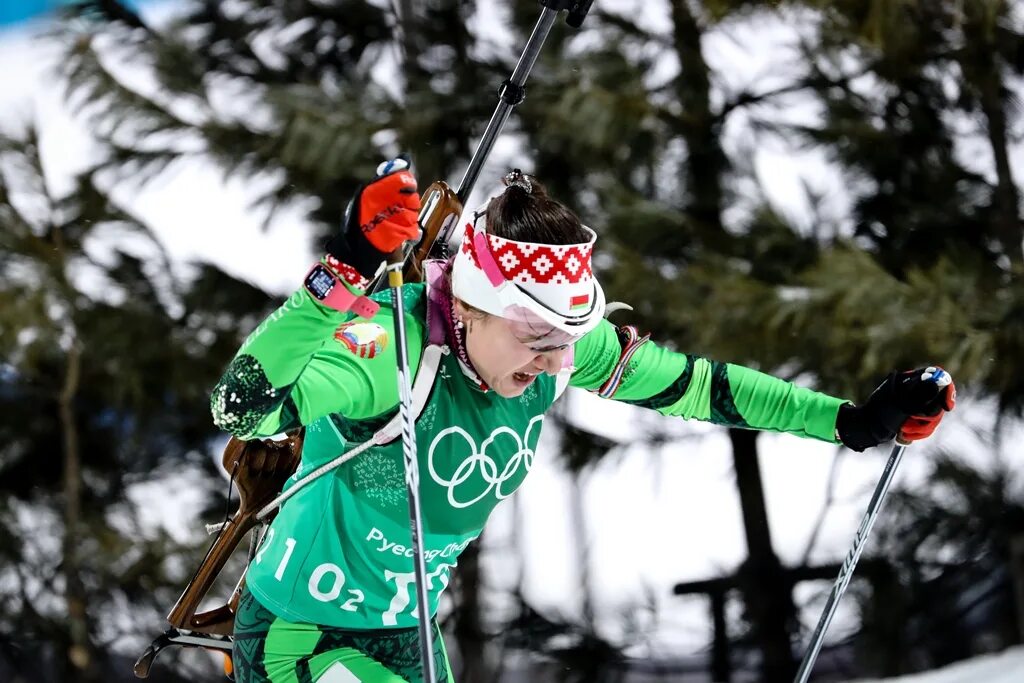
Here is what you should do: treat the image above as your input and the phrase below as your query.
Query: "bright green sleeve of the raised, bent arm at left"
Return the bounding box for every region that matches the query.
[210,285,425,438]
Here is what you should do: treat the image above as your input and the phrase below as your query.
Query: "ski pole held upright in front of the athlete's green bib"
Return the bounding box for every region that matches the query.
[387,255,437,683]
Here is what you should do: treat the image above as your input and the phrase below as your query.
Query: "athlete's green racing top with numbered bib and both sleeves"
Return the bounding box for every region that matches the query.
[211,274,844,683]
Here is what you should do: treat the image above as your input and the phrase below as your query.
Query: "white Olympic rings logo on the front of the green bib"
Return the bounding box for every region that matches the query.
[427,415,544,508]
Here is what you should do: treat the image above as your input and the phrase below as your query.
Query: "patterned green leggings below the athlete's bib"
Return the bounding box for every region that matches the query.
[231,590,454,683]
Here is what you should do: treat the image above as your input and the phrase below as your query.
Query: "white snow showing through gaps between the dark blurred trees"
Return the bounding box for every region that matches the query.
[0,1,1024,683]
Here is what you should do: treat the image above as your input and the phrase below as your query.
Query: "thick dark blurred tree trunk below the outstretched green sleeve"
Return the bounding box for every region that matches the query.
[729,429,797,683]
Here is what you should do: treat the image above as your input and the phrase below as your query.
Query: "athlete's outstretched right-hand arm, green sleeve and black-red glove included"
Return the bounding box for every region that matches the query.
[571,321,956,451]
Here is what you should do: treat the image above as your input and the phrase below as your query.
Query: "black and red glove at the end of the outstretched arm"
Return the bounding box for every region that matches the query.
[836,366,956,451]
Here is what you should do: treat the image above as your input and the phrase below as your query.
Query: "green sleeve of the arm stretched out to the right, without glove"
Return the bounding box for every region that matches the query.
[570,322,847,443]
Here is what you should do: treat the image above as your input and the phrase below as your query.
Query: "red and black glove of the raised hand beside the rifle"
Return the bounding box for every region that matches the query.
[326,157,420,279]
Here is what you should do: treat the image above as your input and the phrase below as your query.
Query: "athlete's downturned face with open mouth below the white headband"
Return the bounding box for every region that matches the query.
[456,302,569,398]
